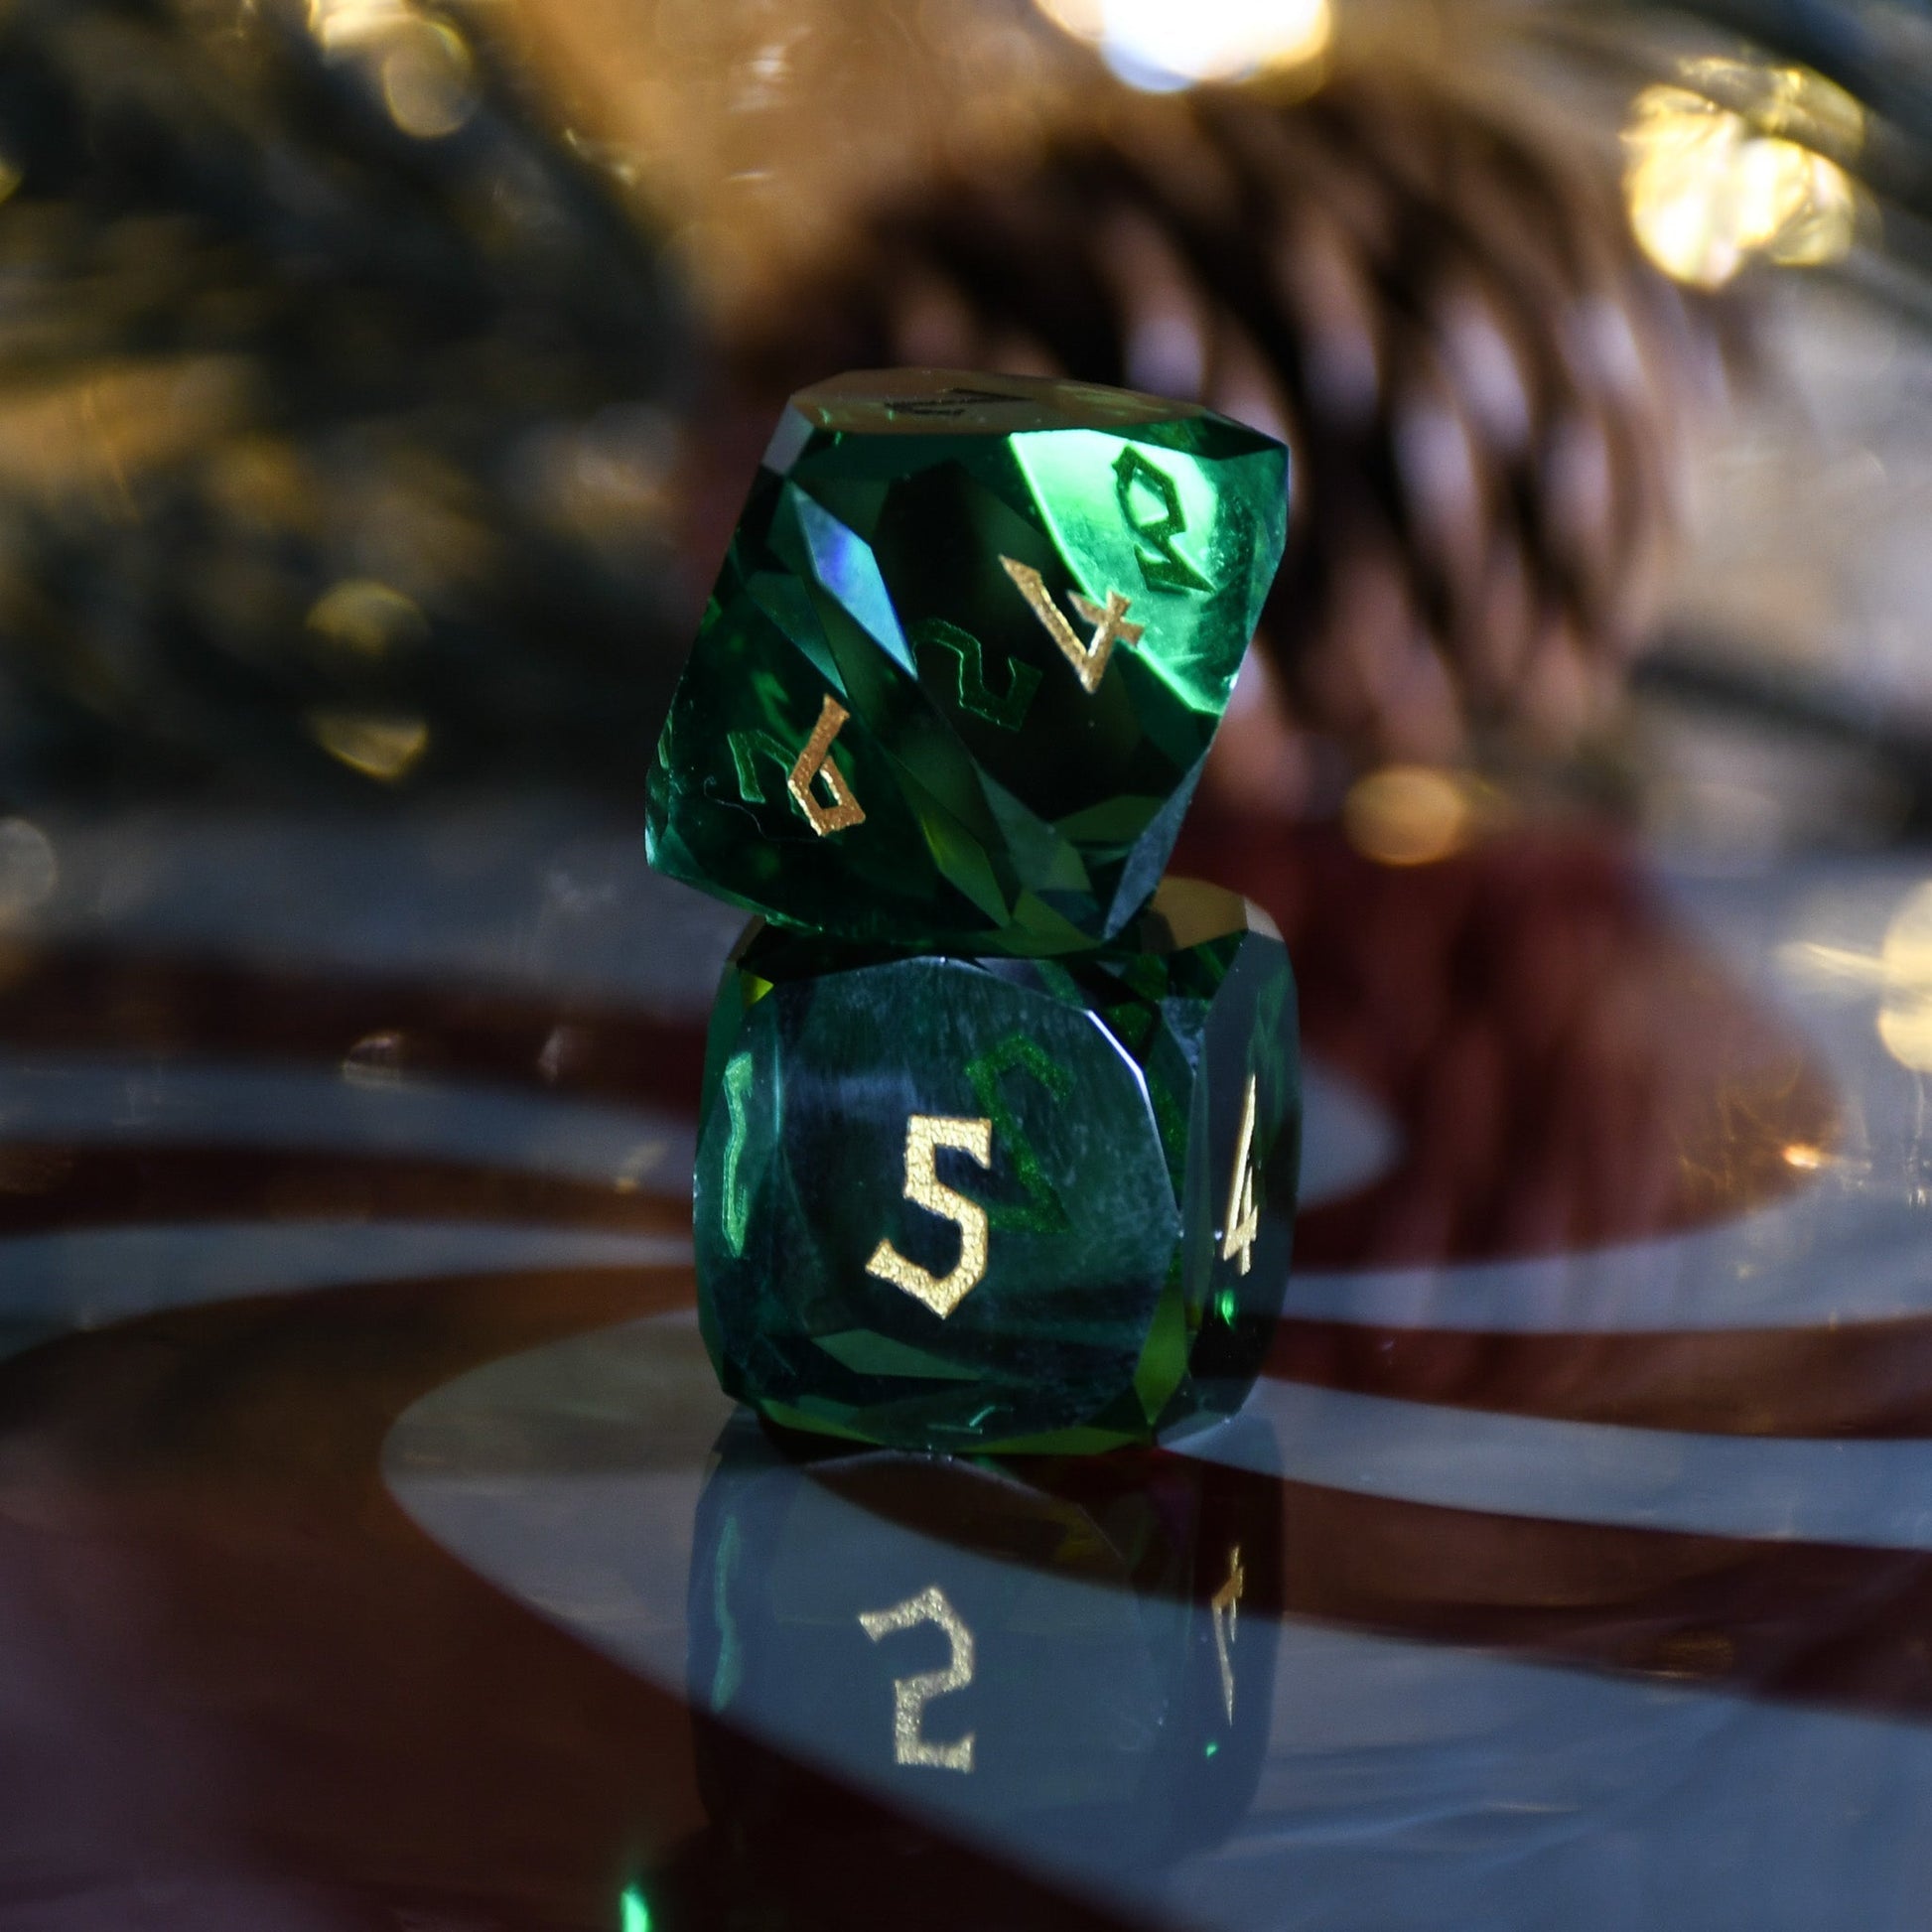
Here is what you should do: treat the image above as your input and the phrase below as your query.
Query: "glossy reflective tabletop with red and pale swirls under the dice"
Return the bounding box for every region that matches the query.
[0,800,1932,1932]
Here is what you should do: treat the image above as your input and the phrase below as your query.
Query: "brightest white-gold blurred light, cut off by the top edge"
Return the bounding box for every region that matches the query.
[1037,0,1335,90]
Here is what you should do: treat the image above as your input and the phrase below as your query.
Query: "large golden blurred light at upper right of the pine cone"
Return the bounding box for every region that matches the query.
[1623,62,1864,288]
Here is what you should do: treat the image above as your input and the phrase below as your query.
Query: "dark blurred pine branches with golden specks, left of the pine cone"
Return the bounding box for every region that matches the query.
[0,0,692,802]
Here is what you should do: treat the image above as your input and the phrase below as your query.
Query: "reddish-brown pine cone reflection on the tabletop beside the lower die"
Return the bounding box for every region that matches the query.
[1174,817,1836,1268]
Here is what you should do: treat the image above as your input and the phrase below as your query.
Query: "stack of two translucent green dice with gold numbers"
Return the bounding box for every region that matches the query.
[649,371,1301,1452]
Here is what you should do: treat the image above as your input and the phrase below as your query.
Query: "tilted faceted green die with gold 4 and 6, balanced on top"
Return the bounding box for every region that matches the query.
[647,371,1287,956]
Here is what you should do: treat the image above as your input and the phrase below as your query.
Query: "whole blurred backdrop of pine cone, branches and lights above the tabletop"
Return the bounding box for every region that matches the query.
[0,0,1932,869]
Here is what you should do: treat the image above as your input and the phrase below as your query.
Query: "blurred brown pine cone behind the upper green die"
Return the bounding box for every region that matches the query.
[736,77,1716,776]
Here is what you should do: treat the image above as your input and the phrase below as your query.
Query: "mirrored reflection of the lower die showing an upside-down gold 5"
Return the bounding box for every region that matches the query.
[690,1416,1281,1881]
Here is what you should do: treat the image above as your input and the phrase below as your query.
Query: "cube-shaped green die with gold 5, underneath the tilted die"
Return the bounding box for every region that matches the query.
[696,881,1301,1450]
